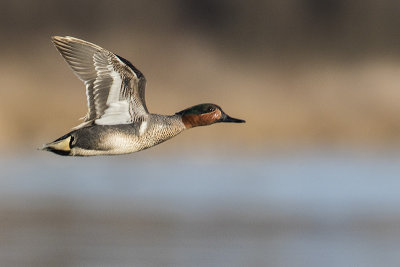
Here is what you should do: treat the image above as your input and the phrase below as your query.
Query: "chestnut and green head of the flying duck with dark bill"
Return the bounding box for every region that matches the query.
[176,104,245,128]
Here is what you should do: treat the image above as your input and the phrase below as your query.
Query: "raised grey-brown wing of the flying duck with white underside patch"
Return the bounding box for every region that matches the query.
[52,36,148,127]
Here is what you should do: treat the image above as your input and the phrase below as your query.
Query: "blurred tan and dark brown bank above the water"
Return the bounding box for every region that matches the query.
[0,0,400,151]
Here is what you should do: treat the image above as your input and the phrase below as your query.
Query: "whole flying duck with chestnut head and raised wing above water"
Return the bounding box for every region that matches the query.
[41,36,245,156]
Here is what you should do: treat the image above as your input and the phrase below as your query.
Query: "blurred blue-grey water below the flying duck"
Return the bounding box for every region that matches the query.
[0,151,400,266]
